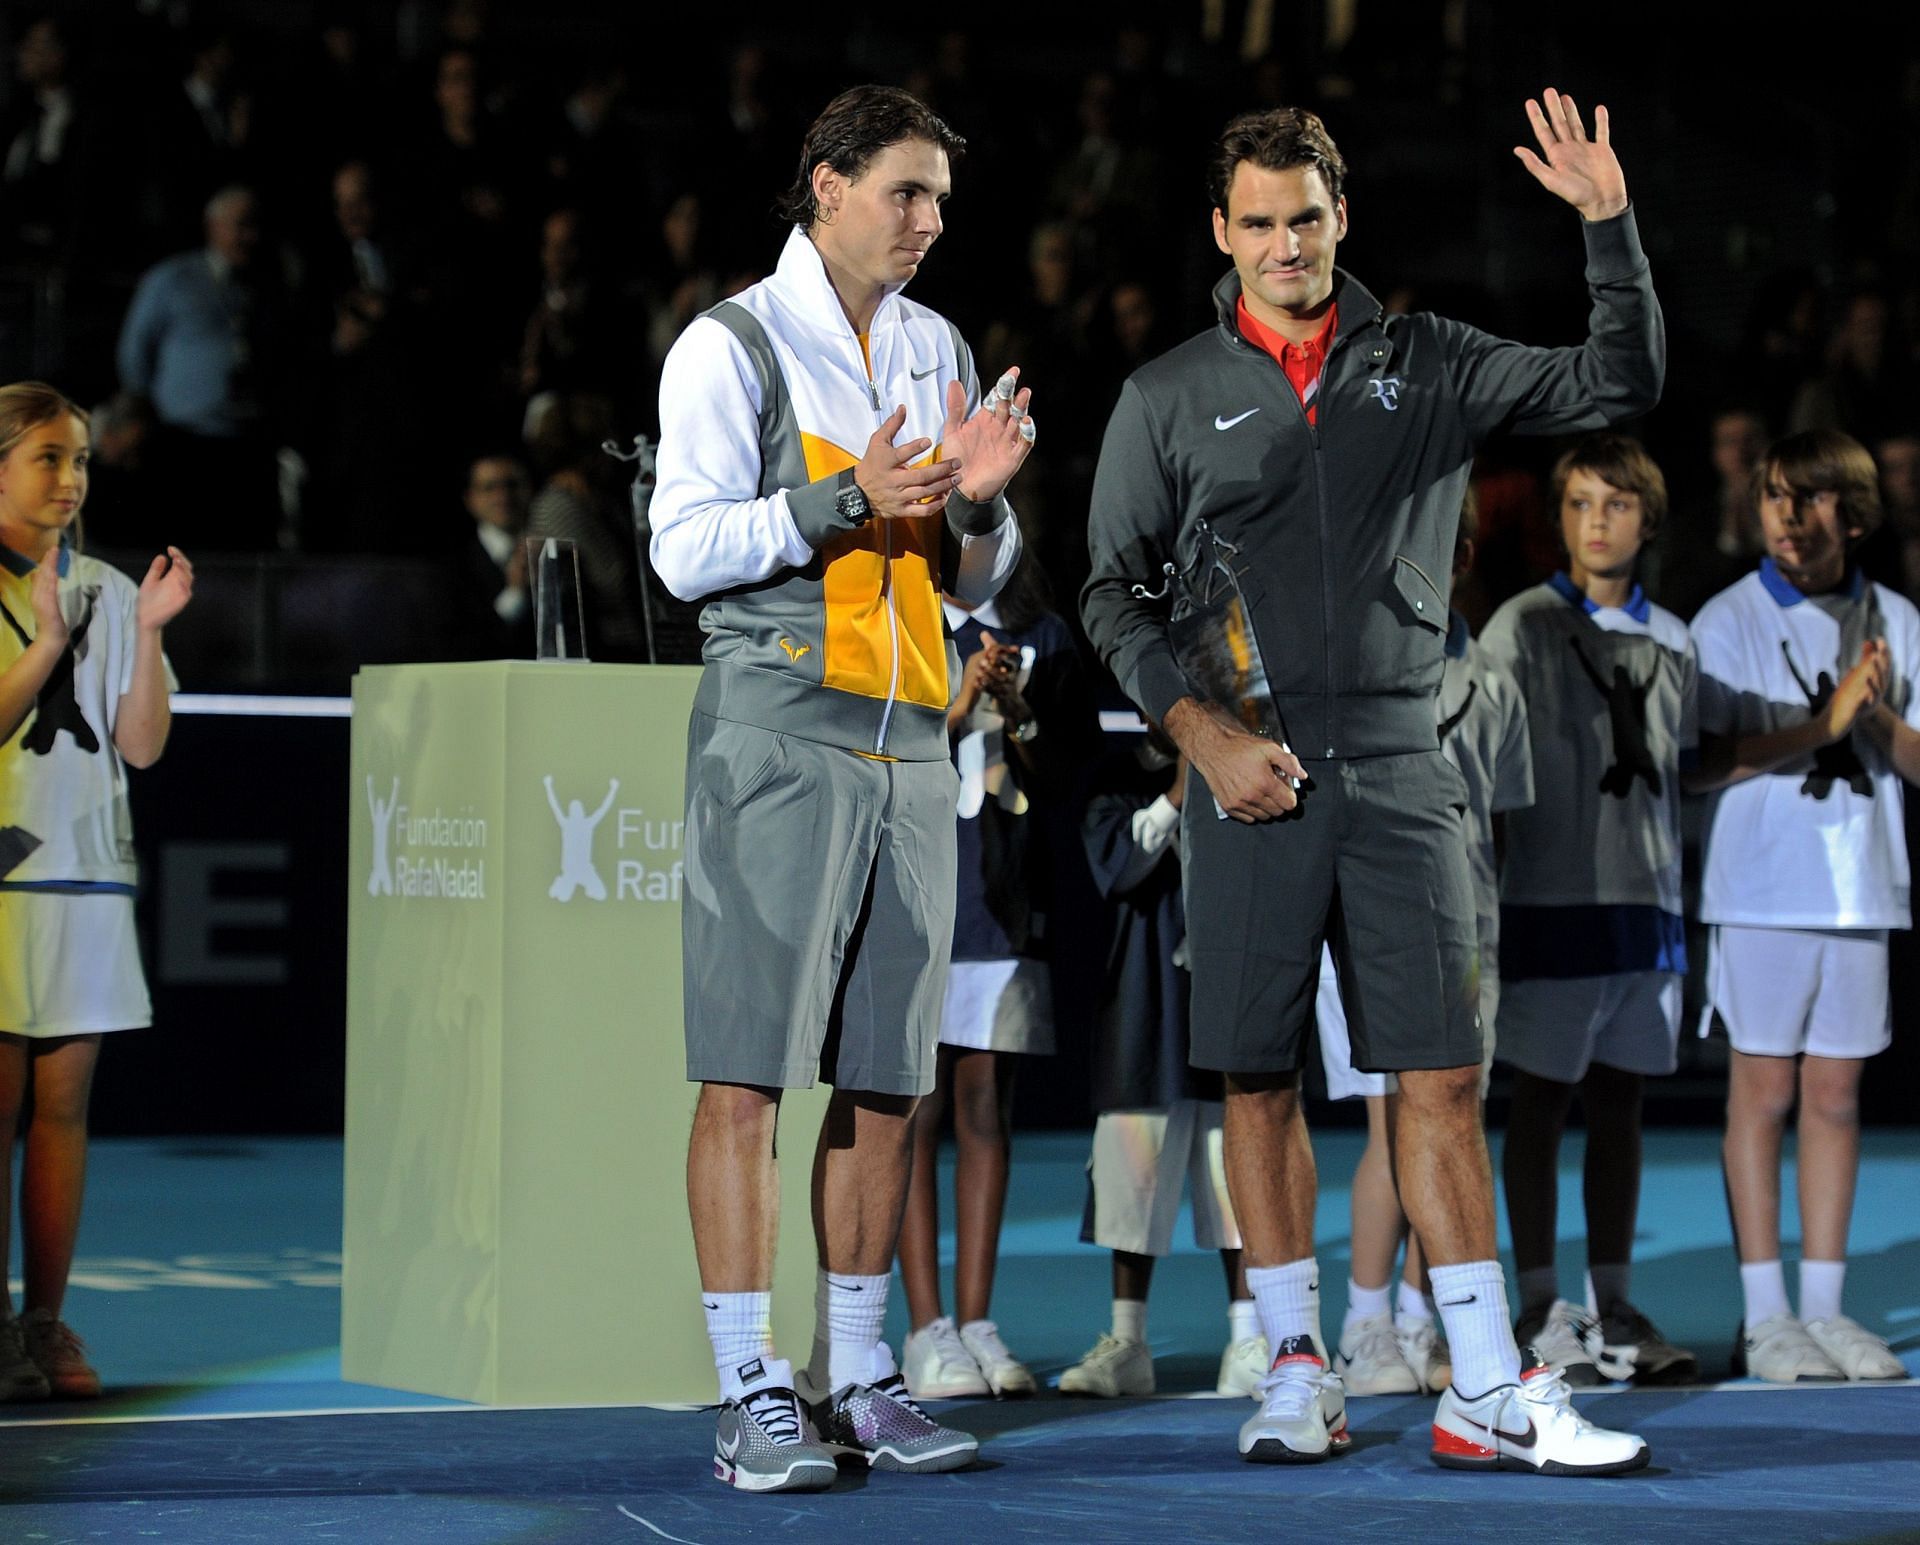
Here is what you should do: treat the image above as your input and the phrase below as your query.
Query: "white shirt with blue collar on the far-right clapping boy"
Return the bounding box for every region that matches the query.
[1693,559,1920,929]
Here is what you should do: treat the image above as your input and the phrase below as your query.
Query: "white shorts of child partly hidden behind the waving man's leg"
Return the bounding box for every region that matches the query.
[1081,1100,1240,1255]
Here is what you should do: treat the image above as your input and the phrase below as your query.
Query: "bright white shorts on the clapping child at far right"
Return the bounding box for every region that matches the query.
[1707,925,1893,1059]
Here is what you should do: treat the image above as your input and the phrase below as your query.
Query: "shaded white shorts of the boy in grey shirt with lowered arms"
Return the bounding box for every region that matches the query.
[1498,971,1680,1084]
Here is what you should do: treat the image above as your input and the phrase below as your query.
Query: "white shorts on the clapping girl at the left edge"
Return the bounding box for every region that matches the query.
[0,891,154,1038]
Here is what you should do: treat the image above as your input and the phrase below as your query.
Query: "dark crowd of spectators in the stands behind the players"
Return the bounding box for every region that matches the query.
[0,0,1920,658]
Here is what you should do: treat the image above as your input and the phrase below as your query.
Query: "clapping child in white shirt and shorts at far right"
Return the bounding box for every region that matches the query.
[1688,430,1920,1384]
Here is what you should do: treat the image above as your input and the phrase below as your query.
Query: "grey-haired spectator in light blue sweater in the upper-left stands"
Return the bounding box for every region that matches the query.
[119,186,292,551]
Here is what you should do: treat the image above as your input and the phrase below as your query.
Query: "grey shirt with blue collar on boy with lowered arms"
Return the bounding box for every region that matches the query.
[1480,574,1699,981]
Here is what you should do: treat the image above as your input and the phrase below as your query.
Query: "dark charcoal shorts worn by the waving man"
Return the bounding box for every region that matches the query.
[1183,750,1482,1073]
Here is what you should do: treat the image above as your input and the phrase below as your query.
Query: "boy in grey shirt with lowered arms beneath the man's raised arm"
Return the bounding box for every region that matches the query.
[1480,434,1699,1384]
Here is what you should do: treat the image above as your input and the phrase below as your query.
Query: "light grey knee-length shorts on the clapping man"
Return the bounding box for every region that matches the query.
[680,710,958,1094]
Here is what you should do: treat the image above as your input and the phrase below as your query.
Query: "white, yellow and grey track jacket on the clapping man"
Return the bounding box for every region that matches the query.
[651,230,1020,762]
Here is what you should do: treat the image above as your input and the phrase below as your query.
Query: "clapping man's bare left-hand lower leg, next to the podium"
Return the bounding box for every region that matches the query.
[687,1084,780,1294]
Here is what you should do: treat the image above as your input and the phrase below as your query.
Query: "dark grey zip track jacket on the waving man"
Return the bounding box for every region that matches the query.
[1081,211,1667,758]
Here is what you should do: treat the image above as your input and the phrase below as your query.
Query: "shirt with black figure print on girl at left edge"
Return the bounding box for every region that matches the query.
[0,545,162,894]
